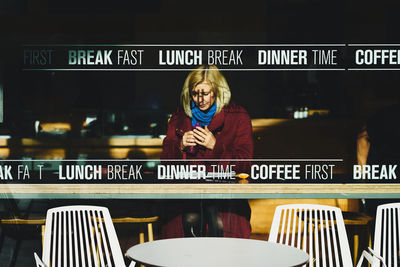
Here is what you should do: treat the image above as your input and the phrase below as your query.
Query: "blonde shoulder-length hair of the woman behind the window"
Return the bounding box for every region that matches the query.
[181,65,231,118]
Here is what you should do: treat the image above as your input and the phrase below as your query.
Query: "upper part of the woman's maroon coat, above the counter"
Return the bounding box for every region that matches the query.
[161,102,253,173]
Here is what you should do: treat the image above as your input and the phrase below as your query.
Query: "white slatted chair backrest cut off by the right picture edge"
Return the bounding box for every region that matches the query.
[373,203,400,267]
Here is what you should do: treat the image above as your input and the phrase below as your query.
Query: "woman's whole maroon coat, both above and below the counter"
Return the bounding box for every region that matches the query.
[161,102,253,238]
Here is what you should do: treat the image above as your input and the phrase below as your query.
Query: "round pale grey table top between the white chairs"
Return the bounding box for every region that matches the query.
[126,237,309,267]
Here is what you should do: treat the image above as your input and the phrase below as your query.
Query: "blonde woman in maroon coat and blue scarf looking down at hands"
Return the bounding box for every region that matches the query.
[161,66,253,238]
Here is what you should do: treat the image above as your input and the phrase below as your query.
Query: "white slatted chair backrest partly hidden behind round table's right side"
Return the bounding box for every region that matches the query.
[268,204,353,267]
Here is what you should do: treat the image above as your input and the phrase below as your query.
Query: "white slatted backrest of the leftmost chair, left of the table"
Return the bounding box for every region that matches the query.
[42,206,125,267]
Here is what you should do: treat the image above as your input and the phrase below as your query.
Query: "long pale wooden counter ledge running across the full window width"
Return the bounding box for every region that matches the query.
[0,184,400,199]
